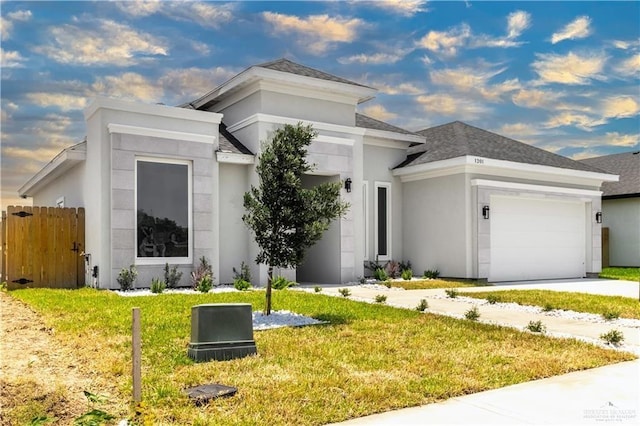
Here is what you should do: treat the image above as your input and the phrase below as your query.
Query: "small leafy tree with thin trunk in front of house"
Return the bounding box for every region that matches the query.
[242,123,349,315]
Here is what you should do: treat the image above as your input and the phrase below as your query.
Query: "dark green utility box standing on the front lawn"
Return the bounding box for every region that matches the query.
[187,303,258,362]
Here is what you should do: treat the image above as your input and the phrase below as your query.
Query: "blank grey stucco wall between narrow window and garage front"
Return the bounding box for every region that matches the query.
[403,174,467,277]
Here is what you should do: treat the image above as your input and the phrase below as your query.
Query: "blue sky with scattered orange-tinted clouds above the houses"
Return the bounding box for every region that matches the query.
[0,0,640,209]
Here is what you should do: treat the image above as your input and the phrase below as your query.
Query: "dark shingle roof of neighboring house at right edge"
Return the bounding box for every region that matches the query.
[580,151,640,199]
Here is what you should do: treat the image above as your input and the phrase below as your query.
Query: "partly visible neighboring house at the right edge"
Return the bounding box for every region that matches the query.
[581,151,640,268]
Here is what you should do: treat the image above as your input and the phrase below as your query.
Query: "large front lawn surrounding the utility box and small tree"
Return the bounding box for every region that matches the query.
[10,283,633,425]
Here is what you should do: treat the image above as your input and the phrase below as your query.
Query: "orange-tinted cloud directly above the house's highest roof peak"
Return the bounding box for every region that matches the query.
[262,12,365,54]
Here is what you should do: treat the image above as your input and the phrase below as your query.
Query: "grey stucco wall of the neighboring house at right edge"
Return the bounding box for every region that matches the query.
[602,198,640,267]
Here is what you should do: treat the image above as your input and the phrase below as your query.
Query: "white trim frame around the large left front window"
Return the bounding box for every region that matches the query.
[133,156,194,265]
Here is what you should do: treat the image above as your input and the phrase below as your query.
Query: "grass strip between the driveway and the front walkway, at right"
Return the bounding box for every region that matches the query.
[460,290,640,319]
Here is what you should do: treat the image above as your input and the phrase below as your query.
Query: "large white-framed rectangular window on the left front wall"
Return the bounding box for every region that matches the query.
[136,158,193,264]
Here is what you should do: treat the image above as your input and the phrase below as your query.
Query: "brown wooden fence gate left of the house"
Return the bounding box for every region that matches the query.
[1,206,85,289]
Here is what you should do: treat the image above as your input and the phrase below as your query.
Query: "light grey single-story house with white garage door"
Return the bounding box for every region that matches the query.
[19,59,617,288]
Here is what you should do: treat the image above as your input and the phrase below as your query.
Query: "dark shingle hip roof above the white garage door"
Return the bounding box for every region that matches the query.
[396,121,602,173]
